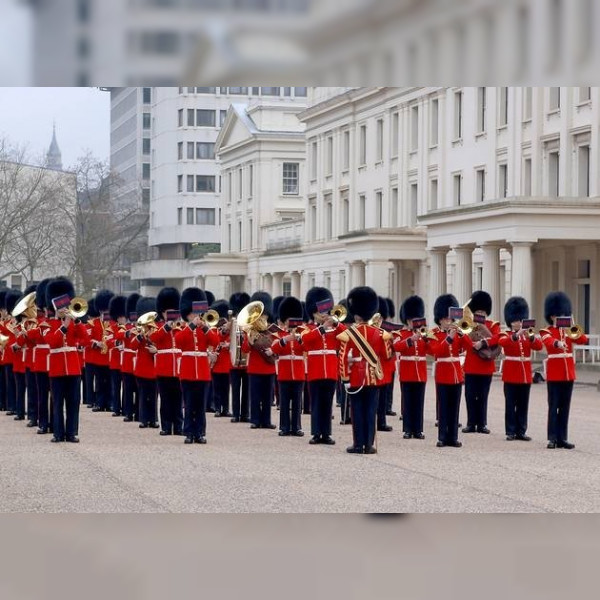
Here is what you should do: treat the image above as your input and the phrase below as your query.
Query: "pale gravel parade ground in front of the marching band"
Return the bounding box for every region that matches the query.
[0,374,600,513]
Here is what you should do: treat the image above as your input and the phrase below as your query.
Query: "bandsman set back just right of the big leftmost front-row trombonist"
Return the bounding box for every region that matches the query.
[87,290,114,412]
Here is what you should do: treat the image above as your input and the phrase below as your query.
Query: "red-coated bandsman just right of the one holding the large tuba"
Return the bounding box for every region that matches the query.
[271,296,306,437]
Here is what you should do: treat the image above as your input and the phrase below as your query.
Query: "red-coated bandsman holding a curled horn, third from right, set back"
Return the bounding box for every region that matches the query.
[463,291,500,433]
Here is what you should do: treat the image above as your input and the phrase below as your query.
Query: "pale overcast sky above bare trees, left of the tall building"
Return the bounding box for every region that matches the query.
[0,87,110,168]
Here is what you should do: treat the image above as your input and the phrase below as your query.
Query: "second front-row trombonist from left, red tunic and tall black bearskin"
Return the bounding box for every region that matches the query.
[175,287,219,444]
